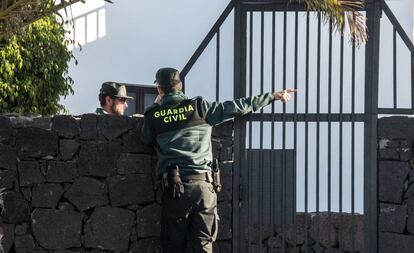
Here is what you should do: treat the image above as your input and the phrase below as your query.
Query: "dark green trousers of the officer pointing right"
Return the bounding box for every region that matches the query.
[161,181,218,253]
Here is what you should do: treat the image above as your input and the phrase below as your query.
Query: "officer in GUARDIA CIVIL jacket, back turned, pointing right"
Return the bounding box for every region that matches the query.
[141,68,296,253]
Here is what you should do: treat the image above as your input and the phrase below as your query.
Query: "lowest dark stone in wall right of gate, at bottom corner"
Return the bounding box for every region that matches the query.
[378,232,414,253]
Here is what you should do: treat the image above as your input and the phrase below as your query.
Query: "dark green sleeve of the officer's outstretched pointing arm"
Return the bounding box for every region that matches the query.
[202,92,275,126]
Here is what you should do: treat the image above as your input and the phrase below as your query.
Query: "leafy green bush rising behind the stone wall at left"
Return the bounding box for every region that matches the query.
[0,16,73,115]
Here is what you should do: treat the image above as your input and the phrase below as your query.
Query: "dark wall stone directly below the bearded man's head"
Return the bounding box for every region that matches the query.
[98,114,133,140]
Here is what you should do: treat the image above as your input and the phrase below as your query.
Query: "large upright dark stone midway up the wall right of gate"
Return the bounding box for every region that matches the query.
[379,162,410,203]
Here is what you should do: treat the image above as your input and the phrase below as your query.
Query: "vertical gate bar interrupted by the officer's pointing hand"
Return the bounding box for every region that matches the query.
[282,11,287,251]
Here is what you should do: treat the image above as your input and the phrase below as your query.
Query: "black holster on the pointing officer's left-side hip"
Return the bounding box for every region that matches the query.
[161,165,184,199]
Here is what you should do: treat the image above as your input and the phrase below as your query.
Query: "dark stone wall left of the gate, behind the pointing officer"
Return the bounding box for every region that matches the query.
[0,114,233,253]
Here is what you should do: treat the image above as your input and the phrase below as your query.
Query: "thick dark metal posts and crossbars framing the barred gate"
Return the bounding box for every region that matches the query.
[181,0,414,253]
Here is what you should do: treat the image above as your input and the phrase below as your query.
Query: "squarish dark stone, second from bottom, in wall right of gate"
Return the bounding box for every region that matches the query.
[378,204,407,233]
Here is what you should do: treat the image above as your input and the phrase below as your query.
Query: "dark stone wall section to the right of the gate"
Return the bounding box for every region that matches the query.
[378,117,414,253]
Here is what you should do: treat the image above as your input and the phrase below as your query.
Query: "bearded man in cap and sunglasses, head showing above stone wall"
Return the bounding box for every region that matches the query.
[96,82,134,115]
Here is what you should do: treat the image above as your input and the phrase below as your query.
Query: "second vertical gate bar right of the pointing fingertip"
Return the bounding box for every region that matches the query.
[315,13,321,253]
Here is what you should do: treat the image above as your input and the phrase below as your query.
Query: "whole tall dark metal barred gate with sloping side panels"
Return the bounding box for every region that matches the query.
[182,0,414,253]
